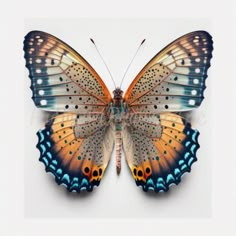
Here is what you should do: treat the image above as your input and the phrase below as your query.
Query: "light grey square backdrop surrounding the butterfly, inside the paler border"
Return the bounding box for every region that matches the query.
[24,19,214,218]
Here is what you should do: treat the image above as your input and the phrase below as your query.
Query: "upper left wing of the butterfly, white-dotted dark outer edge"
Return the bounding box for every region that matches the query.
[24,31,111,113]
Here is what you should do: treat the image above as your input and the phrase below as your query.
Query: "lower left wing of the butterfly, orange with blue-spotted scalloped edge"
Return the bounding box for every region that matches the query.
[37,113,114,192]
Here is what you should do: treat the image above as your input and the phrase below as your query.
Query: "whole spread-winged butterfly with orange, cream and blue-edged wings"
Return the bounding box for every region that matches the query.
[24,31,213,192]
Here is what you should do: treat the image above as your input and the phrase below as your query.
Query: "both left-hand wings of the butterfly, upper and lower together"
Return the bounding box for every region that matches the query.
[24,31,114,192]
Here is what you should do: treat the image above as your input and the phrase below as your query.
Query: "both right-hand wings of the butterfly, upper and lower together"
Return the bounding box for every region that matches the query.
[123,31,213,192]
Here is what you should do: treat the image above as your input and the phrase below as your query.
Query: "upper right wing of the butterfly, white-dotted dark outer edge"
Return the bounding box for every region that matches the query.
[124,31,213,113]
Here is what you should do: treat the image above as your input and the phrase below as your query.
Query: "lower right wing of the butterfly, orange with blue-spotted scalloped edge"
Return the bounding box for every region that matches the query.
[123,113,199,192]
